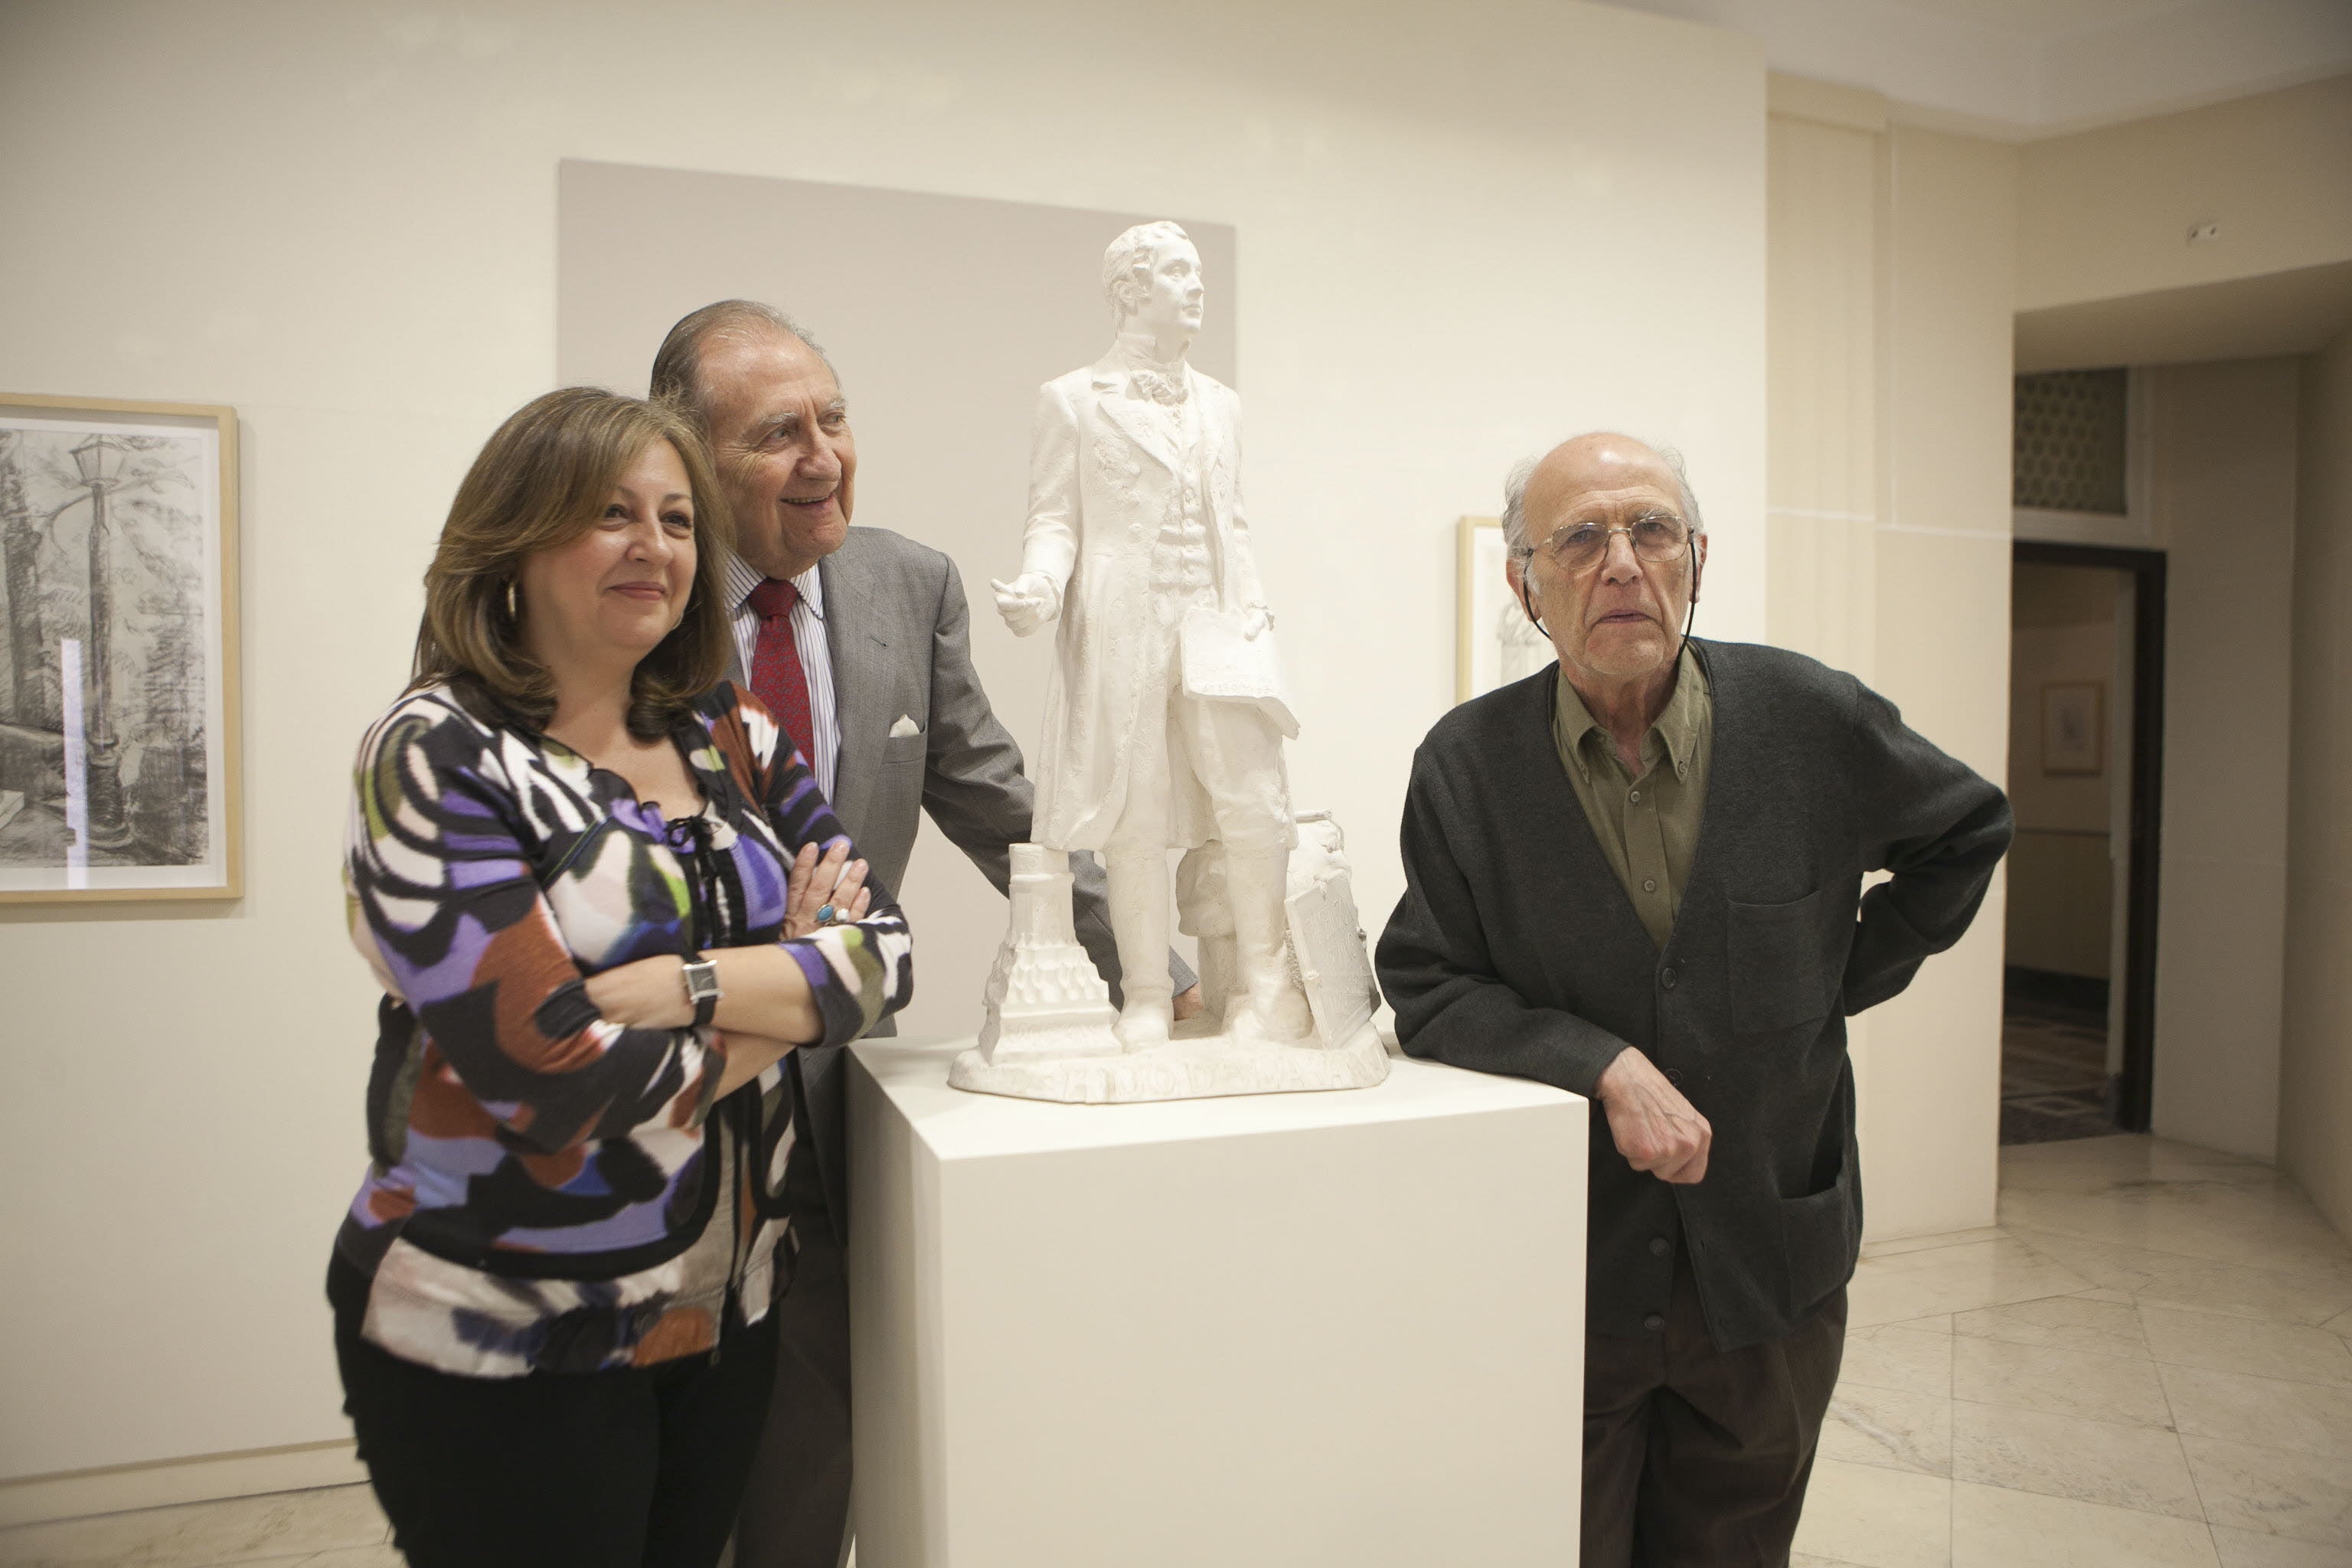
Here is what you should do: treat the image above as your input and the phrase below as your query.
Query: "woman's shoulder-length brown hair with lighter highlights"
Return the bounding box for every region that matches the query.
[410,386,733,740]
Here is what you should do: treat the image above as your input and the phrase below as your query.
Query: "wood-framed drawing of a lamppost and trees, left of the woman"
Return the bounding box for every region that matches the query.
[0,393,242,903]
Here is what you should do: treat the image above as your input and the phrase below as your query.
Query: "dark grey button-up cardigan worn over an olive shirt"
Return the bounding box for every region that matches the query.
[1378,642,2011,1349]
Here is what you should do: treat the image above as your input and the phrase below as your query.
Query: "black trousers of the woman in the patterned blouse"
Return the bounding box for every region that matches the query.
[327,1258,776,1568]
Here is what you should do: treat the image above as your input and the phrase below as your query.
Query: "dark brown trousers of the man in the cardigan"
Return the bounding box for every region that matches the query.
[1583,1256,1847,1568]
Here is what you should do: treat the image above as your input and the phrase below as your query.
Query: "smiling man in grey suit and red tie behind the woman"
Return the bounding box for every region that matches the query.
[652,299,1200,1568]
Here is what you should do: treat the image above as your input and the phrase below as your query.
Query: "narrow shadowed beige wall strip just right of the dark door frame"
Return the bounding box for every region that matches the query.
[2148,360,2295,1159]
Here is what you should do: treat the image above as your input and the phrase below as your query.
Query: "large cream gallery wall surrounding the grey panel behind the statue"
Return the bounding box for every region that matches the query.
[0,0,1766,1476]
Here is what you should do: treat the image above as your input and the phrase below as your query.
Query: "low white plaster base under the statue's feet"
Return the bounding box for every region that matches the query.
[948,1021,1387,1105]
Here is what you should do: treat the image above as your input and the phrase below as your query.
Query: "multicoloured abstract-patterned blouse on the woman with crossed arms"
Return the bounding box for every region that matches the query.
[336,684,913,1377]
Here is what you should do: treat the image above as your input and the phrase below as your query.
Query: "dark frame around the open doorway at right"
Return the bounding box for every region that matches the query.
[2011,538,2164,1133]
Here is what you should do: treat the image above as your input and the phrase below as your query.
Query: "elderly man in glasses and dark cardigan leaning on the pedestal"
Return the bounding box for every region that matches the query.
[1378,435,2011,1568]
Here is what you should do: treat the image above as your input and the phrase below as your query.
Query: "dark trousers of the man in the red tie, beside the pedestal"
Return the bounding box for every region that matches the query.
[733,1142,849,1568]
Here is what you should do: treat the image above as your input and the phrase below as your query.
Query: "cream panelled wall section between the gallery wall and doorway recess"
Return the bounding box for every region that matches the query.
[1766,77,2016,1239]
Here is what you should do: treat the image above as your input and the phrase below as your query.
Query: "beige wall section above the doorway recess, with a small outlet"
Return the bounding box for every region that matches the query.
[2016,75,2352,310]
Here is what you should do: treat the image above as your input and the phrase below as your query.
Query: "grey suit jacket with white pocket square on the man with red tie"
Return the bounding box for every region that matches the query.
[729,529,1193,1241]
